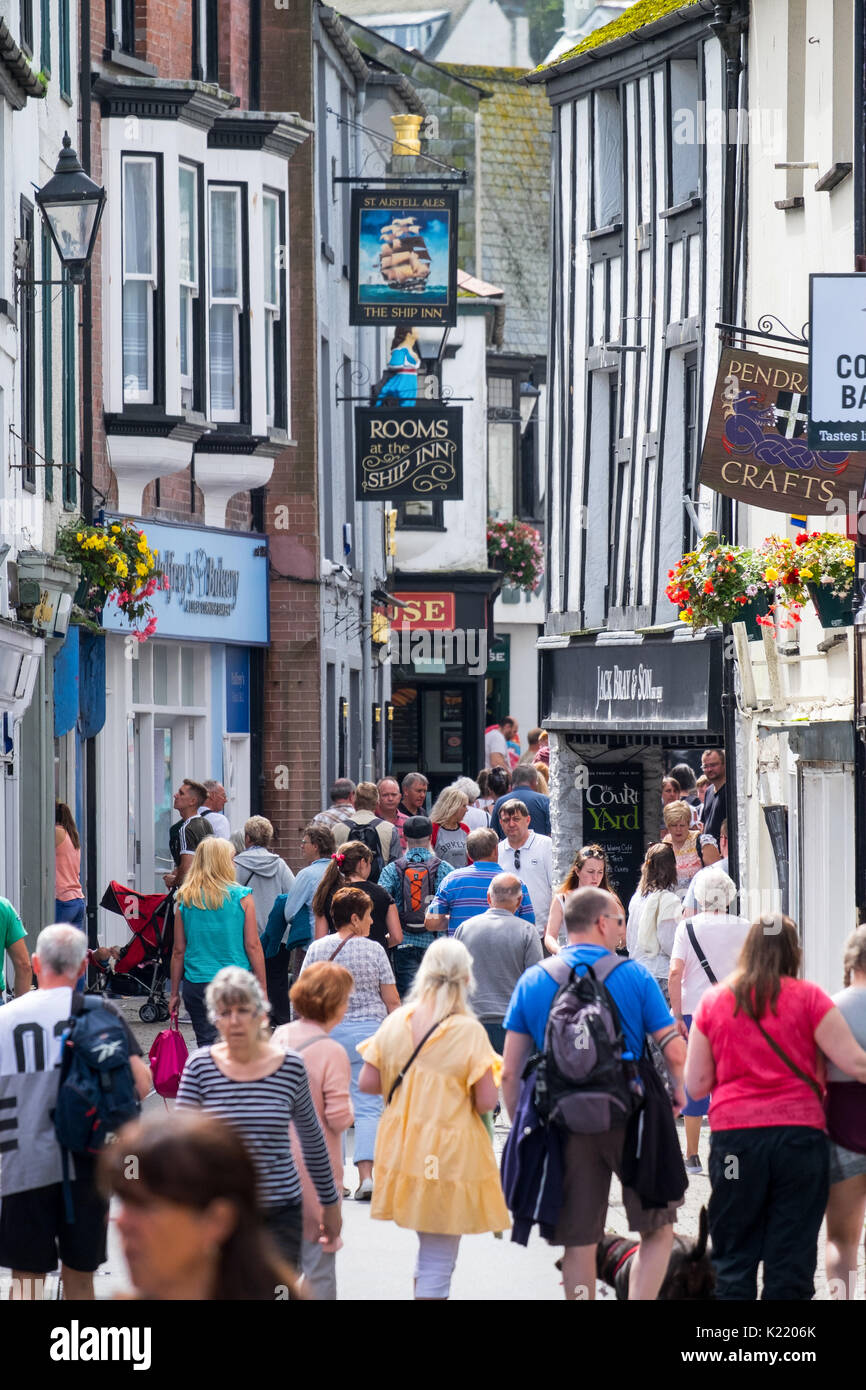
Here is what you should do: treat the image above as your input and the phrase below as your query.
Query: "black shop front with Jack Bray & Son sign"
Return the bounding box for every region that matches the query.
[539,631,723,901]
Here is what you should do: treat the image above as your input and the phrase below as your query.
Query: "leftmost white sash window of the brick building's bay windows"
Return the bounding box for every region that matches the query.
[122,156,158,404]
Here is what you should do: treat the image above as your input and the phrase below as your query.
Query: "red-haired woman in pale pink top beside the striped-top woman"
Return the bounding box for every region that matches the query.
[274,960,354,1300]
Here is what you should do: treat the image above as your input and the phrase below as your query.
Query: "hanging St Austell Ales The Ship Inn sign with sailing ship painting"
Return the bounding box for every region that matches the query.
[350,189,457,328]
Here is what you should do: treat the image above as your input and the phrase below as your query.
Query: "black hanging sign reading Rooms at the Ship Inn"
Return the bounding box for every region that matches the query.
[354,406,463,502]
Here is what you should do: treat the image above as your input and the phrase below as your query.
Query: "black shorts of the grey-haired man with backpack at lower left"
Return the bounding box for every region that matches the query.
[0,1159,108,1275]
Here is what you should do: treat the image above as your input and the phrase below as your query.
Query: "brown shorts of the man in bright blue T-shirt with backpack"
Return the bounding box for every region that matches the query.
[550,1125,685,1245]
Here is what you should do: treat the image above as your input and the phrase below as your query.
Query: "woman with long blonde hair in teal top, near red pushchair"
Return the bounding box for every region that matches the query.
[168,835,267,1047]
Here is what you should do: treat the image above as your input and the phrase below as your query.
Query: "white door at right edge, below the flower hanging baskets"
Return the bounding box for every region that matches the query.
[798,763,856,994]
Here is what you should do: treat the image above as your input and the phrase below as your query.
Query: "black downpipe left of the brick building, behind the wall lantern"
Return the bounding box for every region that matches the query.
[78,0,100,949]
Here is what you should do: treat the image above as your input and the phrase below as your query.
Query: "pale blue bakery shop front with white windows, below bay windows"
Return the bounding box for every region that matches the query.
[97,521,268,944]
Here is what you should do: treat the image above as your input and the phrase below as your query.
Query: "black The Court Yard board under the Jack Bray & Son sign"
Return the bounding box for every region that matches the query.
[581,763,644,908]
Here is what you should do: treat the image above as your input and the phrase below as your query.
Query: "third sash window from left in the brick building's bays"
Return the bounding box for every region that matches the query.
[209,183,243,421]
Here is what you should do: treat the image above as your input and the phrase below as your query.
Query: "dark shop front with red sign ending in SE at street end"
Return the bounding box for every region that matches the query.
[389,573,499,798]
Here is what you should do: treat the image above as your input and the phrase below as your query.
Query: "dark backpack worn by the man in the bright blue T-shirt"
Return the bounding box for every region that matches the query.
[527,952,642,1134]
